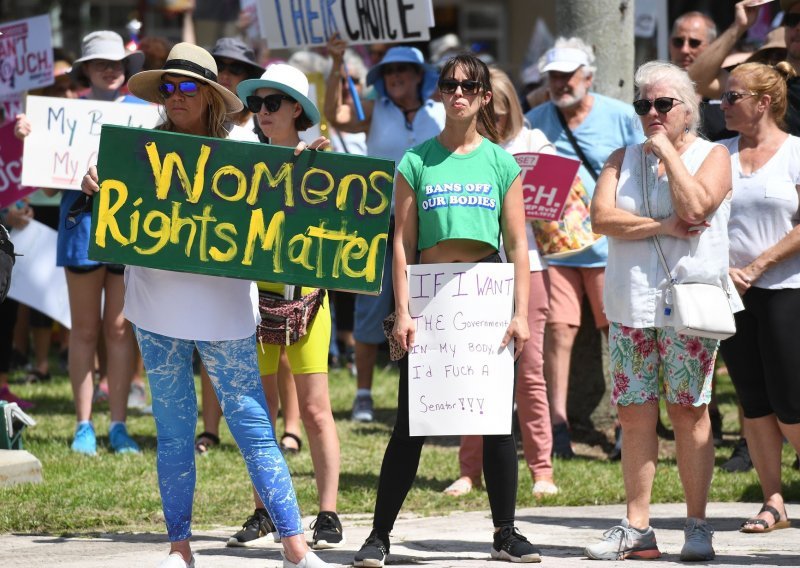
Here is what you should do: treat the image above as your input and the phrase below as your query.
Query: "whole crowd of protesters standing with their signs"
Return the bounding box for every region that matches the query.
[0,0,800,568]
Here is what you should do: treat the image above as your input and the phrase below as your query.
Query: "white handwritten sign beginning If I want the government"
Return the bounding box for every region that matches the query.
[408,263,514,436]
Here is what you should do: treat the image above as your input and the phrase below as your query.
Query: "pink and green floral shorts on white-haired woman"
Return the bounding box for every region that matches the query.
[608,322,719,406]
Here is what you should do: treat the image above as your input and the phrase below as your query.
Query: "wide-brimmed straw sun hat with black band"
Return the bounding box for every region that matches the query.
[128,42,244,113]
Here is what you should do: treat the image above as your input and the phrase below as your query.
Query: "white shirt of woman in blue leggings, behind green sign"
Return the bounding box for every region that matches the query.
[123,121,259,341]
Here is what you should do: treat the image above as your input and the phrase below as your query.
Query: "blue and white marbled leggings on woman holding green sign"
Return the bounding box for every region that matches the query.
[133,326,303,542]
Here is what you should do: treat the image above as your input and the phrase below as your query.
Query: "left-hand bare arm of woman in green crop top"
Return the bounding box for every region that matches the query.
[392,173,419,351]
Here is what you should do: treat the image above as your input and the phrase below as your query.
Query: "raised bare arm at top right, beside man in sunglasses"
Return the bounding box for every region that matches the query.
[687,0,759,99]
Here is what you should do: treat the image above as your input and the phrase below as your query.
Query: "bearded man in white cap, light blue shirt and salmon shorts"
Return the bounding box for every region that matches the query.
[526,37,644,459]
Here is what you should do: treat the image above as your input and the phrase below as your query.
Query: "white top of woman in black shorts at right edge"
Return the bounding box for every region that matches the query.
[720,136,800,289]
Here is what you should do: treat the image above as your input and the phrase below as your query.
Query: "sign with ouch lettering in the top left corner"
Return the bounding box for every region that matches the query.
[0,16,55,95]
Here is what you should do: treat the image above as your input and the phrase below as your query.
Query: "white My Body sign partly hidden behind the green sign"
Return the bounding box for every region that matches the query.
[22,97,159,189]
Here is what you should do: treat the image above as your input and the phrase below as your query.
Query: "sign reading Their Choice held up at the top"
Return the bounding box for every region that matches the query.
[258,0,432,49]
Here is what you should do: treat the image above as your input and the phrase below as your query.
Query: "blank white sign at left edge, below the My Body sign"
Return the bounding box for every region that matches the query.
[8,220,72,328]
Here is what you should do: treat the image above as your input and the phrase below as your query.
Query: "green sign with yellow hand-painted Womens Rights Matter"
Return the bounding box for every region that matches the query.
[89,125,394,294]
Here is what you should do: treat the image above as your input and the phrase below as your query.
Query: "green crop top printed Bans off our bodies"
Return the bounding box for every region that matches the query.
[397,138,520,250]
